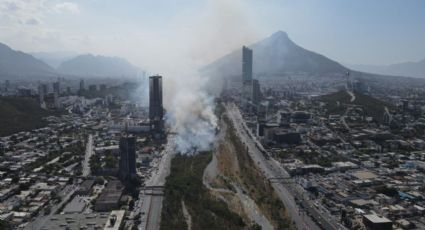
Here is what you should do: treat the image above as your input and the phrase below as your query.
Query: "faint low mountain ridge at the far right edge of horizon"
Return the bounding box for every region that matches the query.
[350,59,425,78]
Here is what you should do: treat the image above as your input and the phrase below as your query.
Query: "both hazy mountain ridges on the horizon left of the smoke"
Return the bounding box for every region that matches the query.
[0,43,141,79]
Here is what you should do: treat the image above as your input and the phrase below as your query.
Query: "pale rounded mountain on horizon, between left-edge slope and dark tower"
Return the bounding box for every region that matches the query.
[57,54,140,77]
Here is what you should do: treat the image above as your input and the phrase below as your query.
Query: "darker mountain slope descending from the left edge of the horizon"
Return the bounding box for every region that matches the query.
[0,43,56,77]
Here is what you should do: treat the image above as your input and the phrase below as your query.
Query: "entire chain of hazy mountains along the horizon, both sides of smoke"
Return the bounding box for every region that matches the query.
[0,31,425,78]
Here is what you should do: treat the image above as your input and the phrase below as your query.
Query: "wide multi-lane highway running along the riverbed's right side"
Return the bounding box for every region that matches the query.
[226,104,340,230]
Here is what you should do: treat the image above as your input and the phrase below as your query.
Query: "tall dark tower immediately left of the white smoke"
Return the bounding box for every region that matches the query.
[149,75,164,133]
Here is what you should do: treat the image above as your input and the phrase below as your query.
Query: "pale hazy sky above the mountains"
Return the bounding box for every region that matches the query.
[0,0,425,70]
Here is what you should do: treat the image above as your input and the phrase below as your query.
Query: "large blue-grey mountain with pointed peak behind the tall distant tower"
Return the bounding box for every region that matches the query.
[202,31,348,76]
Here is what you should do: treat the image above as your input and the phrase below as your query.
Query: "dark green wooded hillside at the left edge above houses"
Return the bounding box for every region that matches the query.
[0,97,49,136]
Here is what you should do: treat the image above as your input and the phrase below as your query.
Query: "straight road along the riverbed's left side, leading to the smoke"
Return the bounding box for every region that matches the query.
[139,136,175,230]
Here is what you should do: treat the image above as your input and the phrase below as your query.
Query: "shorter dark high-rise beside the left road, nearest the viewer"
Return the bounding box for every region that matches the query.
[119,137,136,181]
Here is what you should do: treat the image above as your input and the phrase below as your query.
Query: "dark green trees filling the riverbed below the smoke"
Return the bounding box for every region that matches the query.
[161,152,247,230]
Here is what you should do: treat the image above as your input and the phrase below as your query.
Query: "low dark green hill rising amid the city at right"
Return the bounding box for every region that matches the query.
[318,91,391,122]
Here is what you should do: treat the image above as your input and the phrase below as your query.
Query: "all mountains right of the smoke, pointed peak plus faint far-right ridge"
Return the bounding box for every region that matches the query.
[201,31,425,79]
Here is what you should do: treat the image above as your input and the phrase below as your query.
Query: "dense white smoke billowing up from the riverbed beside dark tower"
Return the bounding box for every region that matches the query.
[159,66,217,154]
